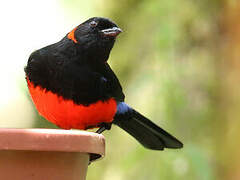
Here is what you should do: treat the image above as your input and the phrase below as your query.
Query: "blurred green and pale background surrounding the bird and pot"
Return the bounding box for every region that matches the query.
[0,0,240,180]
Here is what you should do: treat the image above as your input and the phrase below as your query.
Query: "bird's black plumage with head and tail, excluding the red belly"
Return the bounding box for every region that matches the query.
[25,17,183,150]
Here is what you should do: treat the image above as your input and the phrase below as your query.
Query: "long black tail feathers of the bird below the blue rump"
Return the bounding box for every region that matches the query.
[113,109,183,150]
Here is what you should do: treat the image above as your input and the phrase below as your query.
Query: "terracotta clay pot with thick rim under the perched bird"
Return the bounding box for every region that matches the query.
[0,129,105,180]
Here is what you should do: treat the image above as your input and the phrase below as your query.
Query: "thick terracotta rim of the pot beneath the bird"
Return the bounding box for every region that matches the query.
[0,128,105,161]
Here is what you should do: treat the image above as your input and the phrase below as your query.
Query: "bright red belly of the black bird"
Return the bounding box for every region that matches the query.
[27,79,117,129]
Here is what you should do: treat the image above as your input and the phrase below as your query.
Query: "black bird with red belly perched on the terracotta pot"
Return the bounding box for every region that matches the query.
[25,17,183,150]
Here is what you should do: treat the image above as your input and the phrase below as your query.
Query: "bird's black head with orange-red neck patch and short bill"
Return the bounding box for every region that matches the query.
[67,17,122,61]
